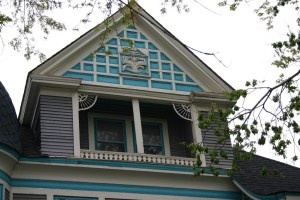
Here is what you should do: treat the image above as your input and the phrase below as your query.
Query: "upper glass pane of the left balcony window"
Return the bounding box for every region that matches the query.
[97,120,124,142]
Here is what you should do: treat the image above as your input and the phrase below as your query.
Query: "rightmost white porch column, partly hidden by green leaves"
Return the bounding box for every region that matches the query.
[191,104,206,166]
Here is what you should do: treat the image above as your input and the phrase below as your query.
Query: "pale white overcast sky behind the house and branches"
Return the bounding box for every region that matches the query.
[0,0,300,167]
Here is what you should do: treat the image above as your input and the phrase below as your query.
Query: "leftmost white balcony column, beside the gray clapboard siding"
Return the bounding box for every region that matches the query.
[72,92,80,157]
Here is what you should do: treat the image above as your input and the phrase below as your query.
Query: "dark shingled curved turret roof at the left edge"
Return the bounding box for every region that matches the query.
[0,81,22,153]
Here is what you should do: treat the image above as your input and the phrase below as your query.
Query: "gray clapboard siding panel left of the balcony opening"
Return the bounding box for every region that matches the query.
[40,95,74,156]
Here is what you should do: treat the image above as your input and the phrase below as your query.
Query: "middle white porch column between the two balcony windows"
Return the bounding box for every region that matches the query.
[132,99,144,153]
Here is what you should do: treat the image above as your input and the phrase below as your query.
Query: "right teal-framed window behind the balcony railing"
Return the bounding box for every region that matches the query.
[142,122,165,155]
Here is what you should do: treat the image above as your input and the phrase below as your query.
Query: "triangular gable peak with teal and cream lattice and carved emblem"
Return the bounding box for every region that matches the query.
[33,4,232,93]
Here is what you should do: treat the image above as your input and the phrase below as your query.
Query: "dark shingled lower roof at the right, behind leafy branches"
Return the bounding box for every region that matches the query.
[233,155,300,195]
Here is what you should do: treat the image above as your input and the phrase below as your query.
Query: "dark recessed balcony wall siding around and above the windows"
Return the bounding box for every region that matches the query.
[79,99,192,157]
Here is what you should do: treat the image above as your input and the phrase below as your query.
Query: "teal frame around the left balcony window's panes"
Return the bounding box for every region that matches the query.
[94,118,127,152]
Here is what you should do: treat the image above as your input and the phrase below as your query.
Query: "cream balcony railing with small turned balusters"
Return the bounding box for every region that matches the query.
[80,149,196,166]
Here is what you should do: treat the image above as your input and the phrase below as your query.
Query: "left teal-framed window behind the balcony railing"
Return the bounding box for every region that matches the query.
[95,119,127,152]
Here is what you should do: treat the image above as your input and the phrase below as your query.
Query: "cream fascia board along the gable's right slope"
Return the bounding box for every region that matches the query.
[138,12,232,92]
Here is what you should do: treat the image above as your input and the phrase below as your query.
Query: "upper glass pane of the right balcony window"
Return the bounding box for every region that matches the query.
[142,124,162,145]
